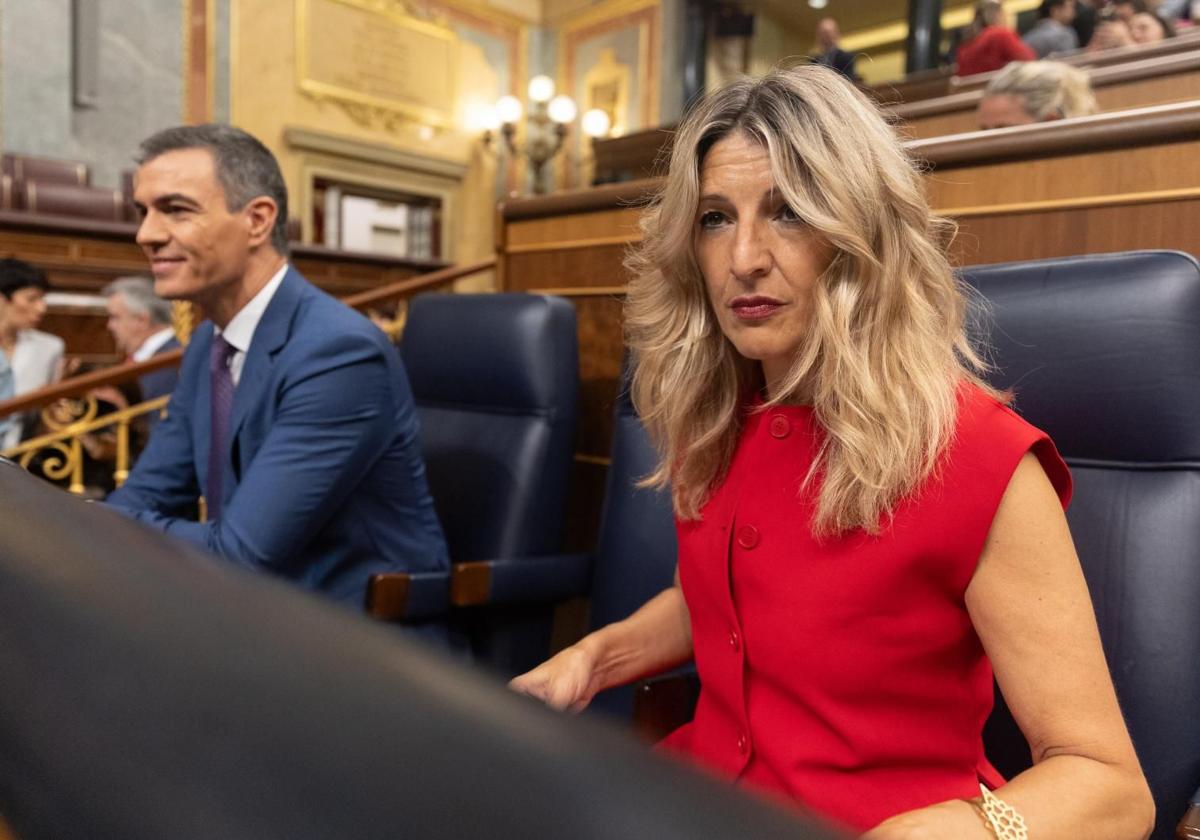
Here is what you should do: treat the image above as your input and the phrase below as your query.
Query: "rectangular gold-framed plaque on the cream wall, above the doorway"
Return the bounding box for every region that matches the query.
[296,0,458,131]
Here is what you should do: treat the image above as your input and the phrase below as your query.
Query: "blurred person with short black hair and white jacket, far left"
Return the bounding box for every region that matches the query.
[0,259,65,449]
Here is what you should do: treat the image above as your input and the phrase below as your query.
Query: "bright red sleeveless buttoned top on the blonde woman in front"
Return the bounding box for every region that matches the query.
[664,386,1070,830]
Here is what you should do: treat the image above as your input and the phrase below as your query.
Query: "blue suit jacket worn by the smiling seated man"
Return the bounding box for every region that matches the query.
[108,268,449,606]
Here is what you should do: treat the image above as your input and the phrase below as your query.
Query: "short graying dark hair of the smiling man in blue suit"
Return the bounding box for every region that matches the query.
[137,122,288,256]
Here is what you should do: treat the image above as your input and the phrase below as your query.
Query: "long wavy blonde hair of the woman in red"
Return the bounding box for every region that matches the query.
[625,66,1000,535]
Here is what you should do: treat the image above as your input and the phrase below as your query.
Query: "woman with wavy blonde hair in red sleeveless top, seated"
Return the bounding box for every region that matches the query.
[512,67,1153,840]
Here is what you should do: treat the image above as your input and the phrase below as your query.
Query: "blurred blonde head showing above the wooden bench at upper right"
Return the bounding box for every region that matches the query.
[976,61,1098,131]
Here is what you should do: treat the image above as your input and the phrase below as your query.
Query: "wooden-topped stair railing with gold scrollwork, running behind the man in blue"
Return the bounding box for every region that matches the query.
[0,259,496,496]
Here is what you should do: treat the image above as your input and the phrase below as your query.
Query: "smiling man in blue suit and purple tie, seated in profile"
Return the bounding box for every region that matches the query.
[108,125,448,608]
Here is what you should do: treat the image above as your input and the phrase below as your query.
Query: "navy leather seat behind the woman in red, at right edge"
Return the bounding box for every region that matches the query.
[964,252,1200,838]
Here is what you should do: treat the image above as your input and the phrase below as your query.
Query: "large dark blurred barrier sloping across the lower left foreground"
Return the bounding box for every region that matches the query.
[0,464,827,840]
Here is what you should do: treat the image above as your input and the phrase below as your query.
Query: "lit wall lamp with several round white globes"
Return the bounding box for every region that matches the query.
[480,76,610,194]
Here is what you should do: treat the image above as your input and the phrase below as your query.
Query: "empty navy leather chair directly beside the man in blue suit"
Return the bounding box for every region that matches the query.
[367,294,578,671]
